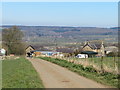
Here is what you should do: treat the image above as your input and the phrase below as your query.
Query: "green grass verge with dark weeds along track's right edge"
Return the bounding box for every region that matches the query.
[39,57,119,88]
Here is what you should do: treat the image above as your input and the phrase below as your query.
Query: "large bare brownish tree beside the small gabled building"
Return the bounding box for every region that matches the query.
[2,26,24,55]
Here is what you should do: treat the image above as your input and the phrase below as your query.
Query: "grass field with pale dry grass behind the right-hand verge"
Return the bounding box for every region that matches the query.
[59,57,119,73]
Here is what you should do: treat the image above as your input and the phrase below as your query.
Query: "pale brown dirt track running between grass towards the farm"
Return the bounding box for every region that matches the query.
[29,59,109,88]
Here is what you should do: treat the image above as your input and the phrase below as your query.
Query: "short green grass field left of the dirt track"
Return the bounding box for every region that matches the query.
[2,58,44,88]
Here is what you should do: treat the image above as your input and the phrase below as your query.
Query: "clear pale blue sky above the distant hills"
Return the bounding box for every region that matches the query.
[2,2,118,27]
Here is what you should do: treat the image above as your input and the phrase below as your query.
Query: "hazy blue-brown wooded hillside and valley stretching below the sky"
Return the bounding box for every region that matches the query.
[0,26,118,44]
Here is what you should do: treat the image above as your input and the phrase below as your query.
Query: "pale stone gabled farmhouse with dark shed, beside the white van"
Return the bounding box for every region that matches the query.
[81,42,105,56]
